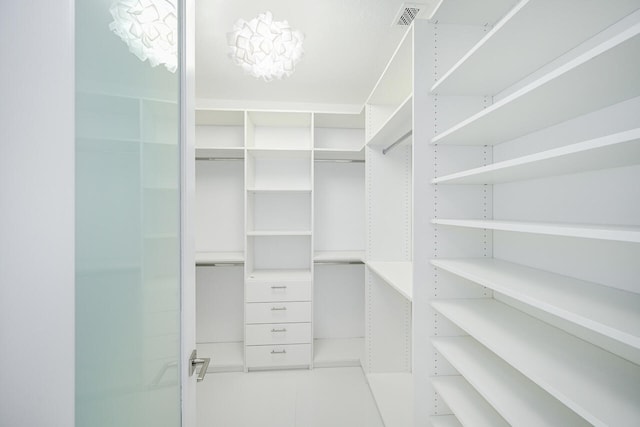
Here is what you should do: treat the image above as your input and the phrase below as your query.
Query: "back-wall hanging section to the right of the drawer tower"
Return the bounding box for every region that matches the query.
[313,111,365,367]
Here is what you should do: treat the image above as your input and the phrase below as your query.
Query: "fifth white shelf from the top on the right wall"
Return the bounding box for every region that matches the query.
[431,259,640,349]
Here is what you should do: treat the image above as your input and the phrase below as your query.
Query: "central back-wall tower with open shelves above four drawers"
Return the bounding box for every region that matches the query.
[244,111,313,370]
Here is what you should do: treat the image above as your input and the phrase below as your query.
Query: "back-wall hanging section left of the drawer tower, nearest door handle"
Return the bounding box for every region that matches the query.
[195,110,245,372]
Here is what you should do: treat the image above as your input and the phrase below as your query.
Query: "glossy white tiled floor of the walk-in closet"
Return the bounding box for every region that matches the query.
[198,367,383,427]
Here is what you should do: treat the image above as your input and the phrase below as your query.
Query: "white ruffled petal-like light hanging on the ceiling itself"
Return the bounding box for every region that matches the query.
[227,12,304,82]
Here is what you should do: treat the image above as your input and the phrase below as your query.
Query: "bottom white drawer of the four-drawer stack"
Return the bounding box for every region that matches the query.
[246,344,311,369]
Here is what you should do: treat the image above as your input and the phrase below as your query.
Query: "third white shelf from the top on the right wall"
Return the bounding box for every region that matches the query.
[431,128,640,184]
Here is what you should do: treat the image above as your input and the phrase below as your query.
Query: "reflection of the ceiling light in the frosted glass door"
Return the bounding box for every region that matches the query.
[109,0,178,73]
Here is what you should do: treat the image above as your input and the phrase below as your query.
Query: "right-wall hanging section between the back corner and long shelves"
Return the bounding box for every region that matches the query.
[363,21,418,426]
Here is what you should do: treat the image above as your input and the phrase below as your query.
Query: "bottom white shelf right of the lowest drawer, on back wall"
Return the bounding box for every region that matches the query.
[313,338,364,368]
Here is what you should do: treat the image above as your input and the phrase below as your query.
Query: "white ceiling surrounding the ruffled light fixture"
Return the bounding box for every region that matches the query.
[195,0,437,111]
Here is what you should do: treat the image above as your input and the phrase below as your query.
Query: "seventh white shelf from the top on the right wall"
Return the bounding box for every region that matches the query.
[431,337,590,426]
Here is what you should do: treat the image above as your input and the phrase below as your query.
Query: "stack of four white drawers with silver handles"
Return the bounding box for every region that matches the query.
[245,273,312,369]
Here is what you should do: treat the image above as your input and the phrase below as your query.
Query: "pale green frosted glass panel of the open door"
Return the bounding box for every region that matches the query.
[74,0,181,427]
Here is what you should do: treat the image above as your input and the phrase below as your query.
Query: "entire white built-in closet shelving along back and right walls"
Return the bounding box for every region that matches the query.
[195,0,640,427]
